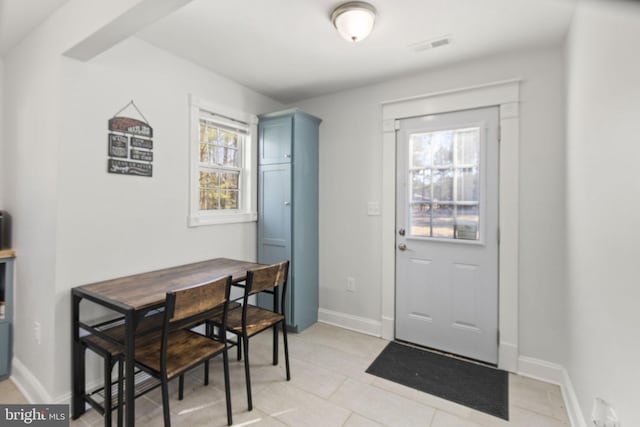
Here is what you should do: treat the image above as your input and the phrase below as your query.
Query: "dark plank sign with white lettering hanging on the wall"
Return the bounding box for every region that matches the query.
[107,101,153,177]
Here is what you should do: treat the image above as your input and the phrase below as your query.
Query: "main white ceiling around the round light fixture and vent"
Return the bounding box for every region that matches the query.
[139,0,575,103]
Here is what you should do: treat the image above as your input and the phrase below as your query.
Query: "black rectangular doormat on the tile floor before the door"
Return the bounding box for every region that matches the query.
[366,342,509,420]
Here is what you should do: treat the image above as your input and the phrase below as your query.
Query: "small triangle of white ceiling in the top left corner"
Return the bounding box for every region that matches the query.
[0,0,68,56]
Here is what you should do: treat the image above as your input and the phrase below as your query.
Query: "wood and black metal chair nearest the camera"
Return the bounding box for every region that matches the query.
[135,276,232,426]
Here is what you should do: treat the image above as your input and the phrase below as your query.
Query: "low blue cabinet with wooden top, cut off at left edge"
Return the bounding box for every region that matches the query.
[0,250,15,380]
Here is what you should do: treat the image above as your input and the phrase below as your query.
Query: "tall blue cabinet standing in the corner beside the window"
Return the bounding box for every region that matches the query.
[258,109,321,332]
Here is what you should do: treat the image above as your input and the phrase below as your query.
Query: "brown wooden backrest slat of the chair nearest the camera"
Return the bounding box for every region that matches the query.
[167,276,231,323]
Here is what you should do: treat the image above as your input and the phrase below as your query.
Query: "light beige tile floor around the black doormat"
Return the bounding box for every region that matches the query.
[0,323,569,427]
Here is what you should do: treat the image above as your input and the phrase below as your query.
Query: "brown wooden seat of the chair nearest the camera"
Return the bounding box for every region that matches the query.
[135,329,224,378]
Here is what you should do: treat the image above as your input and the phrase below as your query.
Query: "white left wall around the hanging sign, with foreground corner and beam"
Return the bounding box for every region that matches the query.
[2,0,281,402]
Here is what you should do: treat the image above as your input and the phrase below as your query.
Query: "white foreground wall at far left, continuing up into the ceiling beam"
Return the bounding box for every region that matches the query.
[2,0,168,401]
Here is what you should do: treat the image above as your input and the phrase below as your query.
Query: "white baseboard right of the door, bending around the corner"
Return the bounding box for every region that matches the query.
[518,356,587,427]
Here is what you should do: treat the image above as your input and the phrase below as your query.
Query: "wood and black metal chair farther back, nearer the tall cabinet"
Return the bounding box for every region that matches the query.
[211,261,291,410]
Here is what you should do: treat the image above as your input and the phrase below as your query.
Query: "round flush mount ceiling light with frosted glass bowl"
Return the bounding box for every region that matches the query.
[331,1,376,43]
